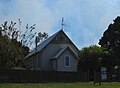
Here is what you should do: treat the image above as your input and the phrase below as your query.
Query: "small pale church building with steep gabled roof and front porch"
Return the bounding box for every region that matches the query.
[26,29,79,72]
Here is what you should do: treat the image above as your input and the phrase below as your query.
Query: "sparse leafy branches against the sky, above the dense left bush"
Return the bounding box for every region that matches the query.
[0,19,36,46]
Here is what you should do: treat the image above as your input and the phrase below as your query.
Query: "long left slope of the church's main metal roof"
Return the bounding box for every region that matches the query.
[25,30,61,58]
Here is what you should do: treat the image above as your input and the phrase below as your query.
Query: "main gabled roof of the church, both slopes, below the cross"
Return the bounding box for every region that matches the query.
[25,30,78,58]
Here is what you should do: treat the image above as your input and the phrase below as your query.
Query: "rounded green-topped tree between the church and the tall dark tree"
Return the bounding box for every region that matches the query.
[78,45,103,70]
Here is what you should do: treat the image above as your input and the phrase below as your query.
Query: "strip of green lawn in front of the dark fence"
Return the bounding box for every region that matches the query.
[0,82,120,88]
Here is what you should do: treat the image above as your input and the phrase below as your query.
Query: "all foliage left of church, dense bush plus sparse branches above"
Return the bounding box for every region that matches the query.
[0,19,48,69]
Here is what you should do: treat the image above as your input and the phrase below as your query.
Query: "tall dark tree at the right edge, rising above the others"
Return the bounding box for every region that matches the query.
[99,16,120,67]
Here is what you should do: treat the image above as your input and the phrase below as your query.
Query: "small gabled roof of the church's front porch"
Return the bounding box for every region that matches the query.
[51,46,78,60]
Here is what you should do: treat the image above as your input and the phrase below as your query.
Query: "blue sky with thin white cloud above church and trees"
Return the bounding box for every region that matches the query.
[0,0,120,49]
